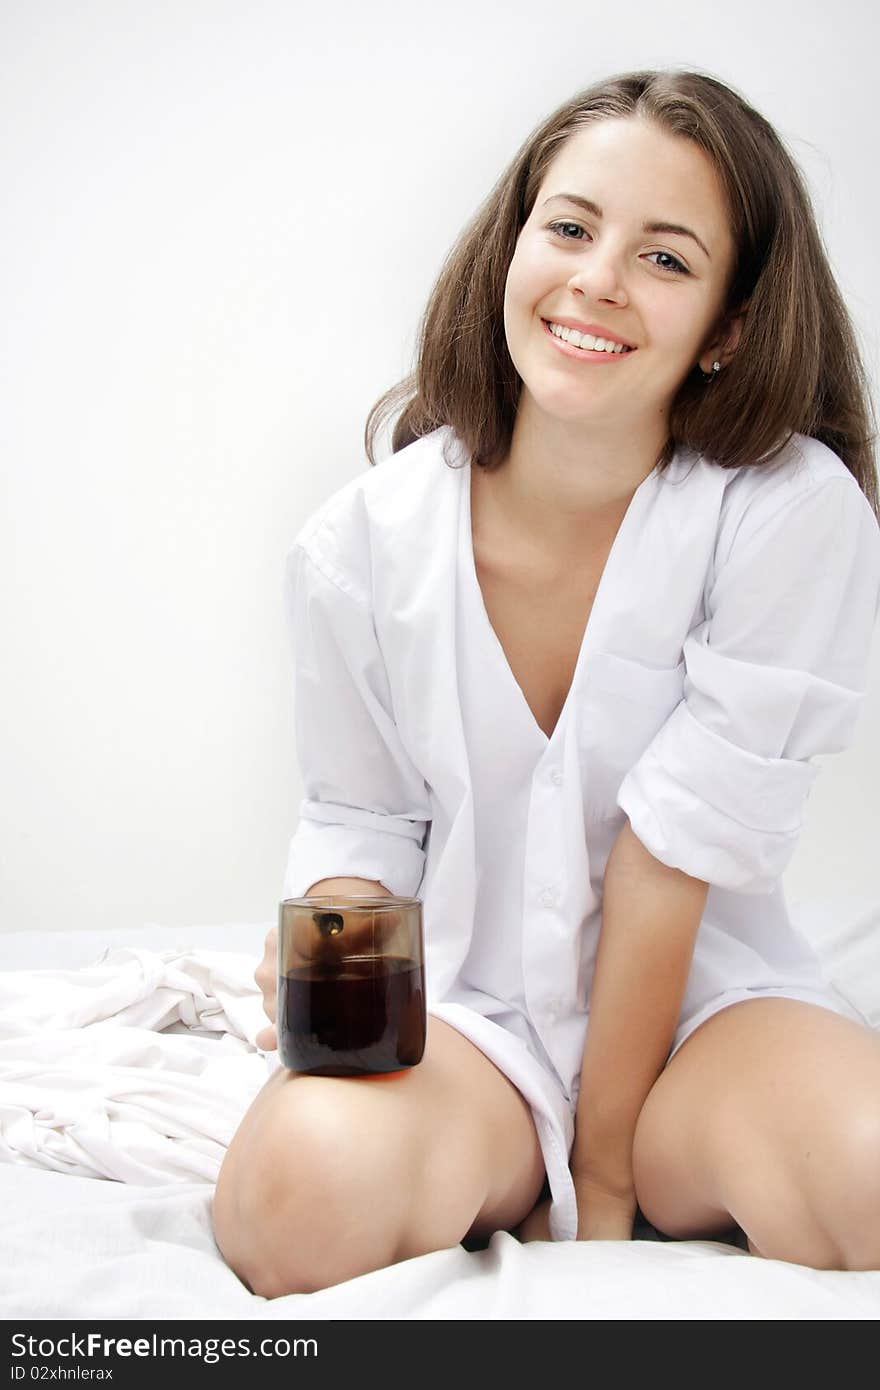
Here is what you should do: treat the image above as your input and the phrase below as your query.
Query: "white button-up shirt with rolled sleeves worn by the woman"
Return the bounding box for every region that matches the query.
[284,427,880,1238]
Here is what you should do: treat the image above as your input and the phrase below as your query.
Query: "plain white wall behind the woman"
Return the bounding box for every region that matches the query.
[0,0,880,934]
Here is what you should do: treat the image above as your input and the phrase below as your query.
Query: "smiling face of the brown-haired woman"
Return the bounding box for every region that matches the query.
[505,118,738,432]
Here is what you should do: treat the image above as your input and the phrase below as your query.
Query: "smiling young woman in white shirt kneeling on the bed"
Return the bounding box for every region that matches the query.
[214,71,880,1297]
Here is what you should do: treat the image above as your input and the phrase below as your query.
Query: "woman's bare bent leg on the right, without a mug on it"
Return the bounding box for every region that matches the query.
[633,998,880,1264]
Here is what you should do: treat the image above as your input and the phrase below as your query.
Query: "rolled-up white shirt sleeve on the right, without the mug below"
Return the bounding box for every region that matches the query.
[617,478,880,894]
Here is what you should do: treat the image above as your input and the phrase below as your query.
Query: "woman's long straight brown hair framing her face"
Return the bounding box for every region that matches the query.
[364,71,880,520]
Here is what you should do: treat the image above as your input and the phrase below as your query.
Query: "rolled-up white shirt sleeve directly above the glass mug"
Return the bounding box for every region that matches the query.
[284,542,430,898]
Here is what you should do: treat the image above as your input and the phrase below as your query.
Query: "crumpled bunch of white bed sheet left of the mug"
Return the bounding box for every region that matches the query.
[0,947,267,1186]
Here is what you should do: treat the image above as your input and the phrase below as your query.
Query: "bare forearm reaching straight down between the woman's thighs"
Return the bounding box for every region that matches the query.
[570,820,709,1200]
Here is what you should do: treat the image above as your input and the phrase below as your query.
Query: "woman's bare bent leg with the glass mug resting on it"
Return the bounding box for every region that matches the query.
[214,1015,545,1277]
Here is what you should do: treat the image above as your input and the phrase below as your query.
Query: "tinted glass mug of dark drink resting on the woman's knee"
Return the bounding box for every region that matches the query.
[277,895,427,1076]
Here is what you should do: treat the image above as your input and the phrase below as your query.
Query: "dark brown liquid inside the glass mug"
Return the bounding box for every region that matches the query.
[278,956,425,1076]
